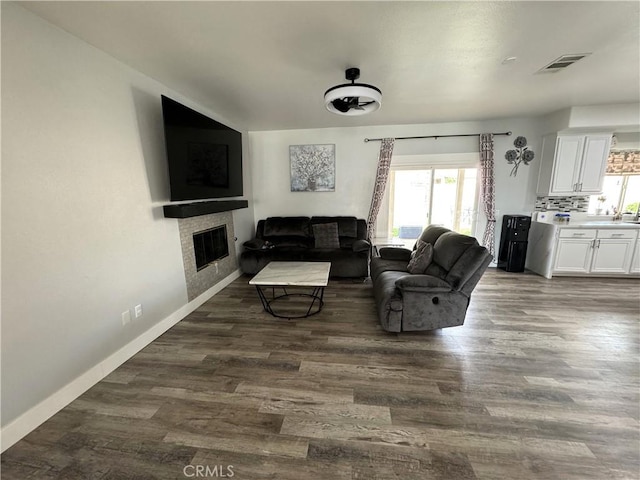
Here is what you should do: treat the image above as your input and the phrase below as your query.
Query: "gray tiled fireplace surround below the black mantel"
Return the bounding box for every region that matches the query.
[178,211,238,301]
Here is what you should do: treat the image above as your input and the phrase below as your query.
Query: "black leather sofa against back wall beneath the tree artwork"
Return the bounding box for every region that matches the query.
[240,216,371,277]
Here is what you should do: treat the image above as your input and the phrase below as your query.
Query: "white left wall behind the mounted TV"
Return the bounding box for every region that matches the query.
[1,2,254,436]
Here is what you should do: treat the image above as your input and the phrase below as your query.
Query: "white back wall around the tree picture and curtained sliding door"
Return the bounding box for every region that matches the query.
[249,117,541,251]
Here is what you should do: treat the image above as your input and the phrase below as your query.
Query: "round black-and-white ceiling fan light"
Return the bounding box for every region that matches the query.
[324,68,382,115]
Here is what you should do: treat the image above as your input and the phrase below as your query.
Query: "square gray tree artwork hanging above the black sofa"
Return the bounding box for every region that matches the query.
[289,144,336,192]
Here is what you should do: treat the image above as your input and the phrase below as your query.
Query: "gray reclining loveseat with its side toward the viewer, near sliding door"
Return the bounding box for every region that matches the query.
[370,226,492,332]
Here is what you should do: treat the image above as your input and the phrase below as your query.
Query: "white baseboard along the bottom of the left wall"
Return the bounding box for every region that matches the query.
[0,270,242,452]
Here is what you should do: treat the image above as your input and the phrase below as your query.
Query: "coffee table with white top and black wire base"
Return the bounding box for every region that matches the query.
[249,262,331,319]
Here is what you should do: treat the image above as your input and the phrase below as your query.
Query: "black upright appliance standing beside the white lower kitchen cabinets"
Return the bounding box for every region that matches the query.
[498,215,531,272]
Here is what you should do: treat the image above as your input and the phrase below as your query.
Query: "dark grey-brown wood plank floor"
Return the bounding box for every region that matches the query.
[2,269,640,480]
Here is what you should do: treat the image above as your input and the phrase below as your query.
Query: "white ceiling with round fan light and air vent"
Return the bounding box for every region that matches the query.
[21,1,640,130]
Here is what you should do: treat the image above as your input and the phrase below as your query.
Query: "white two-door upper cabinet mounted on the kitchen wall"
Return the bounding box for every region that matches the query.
[538,133,611,195]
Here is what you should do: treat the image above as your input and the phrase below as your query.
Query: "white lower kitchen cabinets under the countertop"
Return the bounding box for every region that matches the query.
[553,228,640,275]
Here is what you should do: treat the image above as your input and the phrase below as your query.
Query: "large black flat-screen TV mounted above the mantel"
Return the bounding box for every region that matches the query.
[162,95,242,201]
